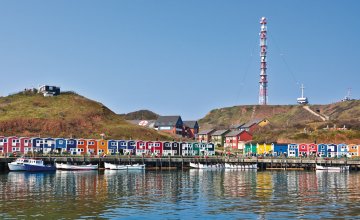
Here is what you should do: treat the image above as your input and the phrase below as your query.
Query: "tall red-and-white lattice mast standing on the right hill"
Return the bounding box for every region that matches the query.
[259,17,268,105]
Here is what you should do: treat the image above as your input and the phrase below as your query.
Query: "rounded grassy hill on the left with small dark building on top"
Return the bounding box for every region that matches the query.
[0,92,173,140]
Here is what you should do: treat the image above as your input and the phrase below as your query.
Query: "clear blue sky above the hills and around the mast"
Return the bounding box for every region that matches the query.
[0,0,360,120]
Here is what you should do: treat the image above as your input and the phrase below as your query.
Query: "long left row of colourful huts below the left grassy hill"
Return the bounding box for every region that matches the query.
[0,136,215,156]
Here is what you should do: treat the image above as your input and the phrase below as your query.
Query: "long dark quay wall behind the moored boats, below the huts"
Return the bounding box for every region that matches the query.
[0,156,360,171]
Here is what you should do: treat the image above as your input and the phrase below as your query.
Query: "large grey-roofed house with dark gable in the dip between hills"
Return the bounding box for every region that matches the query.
[154,116,185,136]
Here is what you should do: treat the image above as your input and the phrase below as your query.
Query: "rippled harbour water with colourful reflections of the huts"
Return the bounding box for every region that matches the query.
[0,170,360,219]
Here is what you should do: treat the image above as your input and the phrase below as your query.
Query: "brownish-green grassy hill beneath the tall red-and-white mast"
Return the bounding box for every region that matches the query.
[199,100,360,144]
